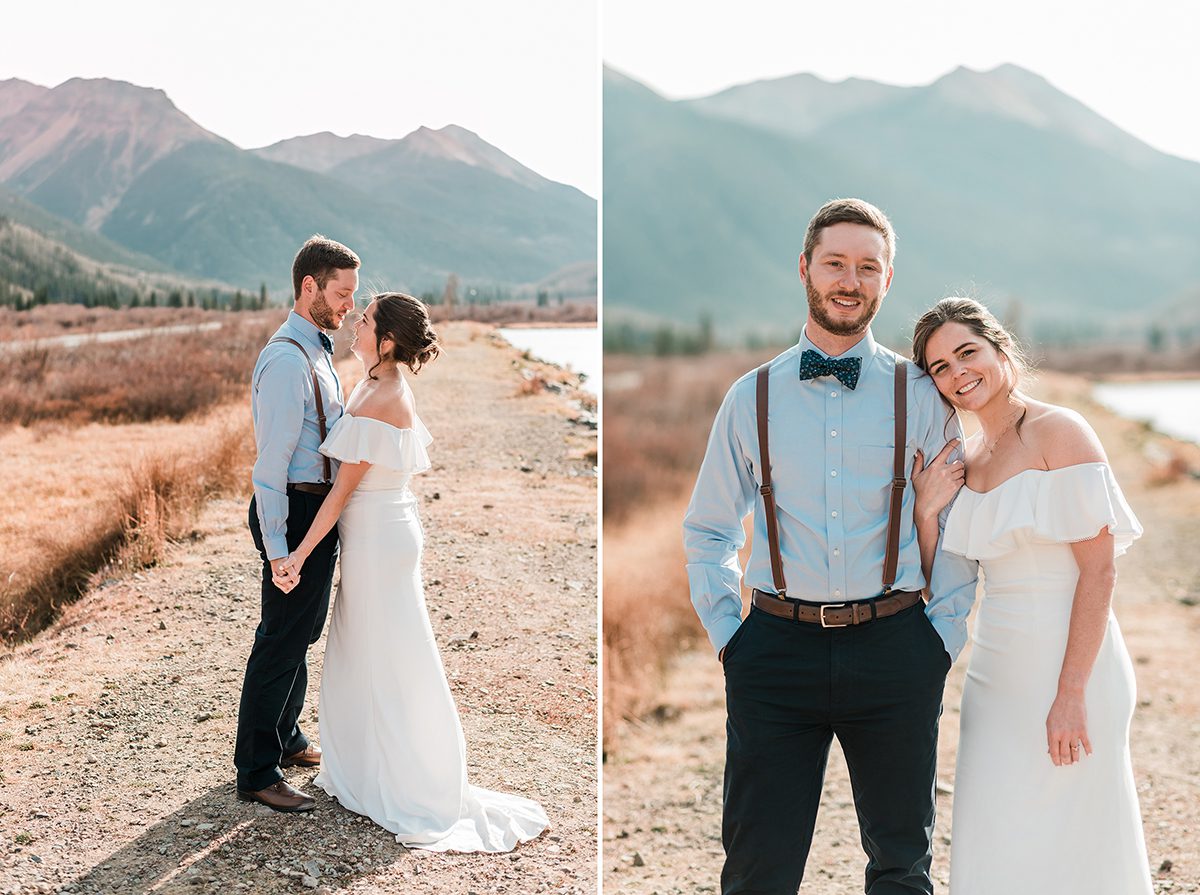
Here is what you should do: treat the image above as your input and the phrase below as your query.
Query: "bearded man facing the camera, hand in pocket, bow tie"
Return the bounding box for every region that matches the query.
[684,199,977,895]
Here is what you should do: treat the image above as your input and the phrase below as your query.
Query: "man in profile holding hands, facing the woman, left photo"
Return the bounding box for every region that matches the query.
[233,236,359,811]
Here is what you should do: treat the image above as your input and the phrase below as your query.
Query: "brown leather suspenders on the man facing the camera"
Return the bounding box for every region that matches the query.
[756,360,908,597]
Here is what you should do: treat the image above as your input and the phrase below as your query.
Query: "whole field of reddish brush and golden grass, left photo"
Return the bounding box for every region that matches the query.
[0,313,278,642]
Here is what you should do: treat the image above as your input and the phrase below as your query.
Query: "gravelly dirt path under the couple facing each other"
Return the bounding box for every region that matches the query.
[0,324,596,895]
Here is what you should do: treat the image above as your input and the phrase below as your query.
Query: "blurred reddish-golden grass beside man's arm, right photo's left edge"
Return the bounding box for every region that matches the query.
[602,353,766,750]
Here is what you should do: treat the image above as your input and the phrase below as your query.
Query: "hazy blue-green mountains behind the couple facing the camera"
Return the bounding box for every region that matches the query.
[604,65,1200,340]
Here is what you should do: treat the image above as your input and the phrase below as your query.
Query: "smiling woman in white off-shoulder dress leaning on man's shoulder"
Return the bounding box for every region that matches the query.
[913,299,1151,895]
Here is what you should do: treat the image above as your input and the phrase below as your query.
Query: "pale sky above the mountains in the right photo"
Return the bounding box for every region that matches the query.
[601,0,1200,160]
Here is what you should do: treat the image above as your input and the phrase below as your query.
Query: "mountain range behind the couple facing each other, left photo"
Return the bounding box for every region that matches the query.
[0,78,596,294]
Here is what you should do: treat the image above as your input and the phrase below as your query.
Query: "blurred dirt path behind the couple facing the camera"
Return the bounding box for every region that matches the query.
[602,384,1200,895]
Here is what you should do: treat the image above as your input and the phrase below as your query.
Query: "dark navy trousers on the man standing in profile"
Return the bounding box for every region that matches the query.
[233,491,337,792]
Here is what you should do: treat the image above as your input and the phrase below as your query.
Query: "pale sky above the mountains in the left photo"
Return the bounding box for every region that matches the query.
[0,0,600,196]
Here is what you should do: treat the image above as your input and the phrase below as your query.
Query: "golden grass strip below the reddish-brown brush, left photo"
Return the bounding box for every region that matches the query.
[0,408,253,642]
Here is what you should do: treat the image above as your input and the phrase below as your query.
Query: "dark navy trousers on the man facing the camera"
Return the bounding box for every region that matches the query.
[721,601,950,895]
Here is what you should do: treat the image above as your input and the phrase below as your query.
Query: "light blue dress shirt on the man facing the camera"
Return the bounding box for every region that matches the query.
[683,330,978,659]
